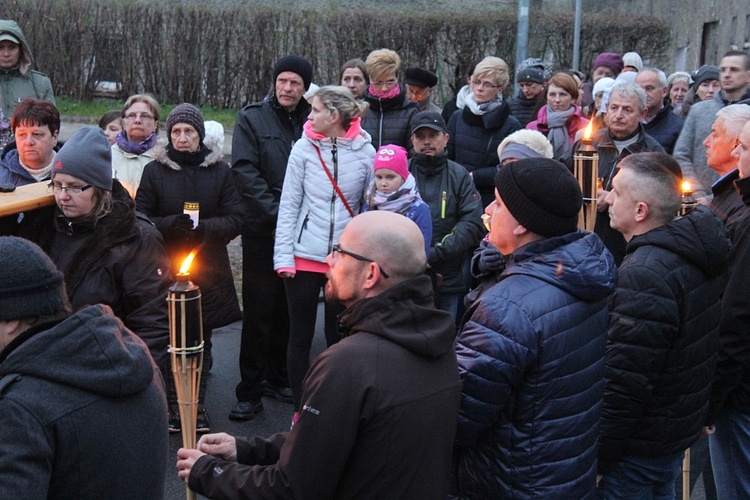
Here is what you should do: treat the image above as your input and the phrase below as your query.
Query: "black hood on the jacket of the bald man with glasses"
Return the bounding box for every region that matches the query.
[339,275,456,358]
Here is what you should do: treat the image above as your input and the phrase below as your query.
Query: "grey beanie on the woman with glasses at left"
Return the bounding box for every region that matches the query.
[52,127,112,191]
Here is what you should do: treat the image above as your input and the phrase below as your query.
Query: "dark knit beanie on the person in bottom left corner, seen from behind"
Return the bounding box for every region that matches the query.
[0,236,68,321]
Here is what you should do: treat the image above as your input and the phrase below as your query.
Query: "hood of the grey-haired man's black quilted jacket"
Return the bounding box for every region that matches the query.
[626,206,730,278]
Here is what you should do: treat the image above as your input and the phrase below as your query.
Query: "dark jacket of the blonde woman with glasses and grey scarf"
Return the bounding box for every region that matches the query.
[448,101,522,207]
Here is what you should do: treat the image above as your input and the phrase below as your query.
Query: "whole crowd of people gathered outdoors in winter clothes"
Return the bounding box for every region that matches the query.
[0,15,750,499]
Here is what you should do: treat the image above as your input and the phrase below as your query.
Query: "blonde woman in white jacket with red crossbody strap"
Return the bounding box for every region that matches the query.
[274,87,375,409]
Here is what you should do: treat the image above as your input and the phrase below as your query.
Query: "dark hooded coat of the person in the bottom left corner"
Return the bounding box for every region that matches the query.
[0,305,169,500]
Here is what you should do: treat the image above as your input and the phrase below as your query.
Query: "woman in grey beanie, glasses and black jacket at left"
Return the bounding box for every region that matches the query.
[18,127,170,386]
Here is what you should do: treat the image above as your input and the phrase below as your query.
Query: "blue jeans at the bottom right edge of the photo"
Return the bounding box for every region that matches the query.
[708,408,750,500]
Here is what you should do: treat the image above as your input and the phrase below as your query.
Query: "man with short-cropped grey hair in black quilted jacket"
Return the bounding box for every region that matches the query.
[599,152,730,498]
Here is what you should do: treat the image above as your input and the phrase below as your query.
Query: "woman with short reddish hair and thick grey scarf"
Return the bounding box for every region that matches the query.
[526,73,589,162]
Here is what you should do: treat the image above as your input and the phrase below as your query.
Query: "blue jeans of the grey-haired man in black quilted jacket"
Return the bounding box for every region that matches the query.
[596,451,685,500]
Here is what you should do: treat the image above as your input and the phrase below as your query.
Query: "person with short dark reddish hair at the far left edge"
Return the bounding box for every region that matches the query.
[0,97,60,186]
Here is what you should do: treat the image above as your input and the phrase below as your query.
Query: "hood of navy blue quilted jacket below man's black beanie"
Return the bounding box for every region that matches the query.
[508,231,617,302]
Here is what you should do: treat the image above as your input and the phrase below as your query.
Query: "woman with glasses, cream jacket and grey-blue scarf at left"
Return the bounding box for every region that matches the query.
[112,94,160,198]
